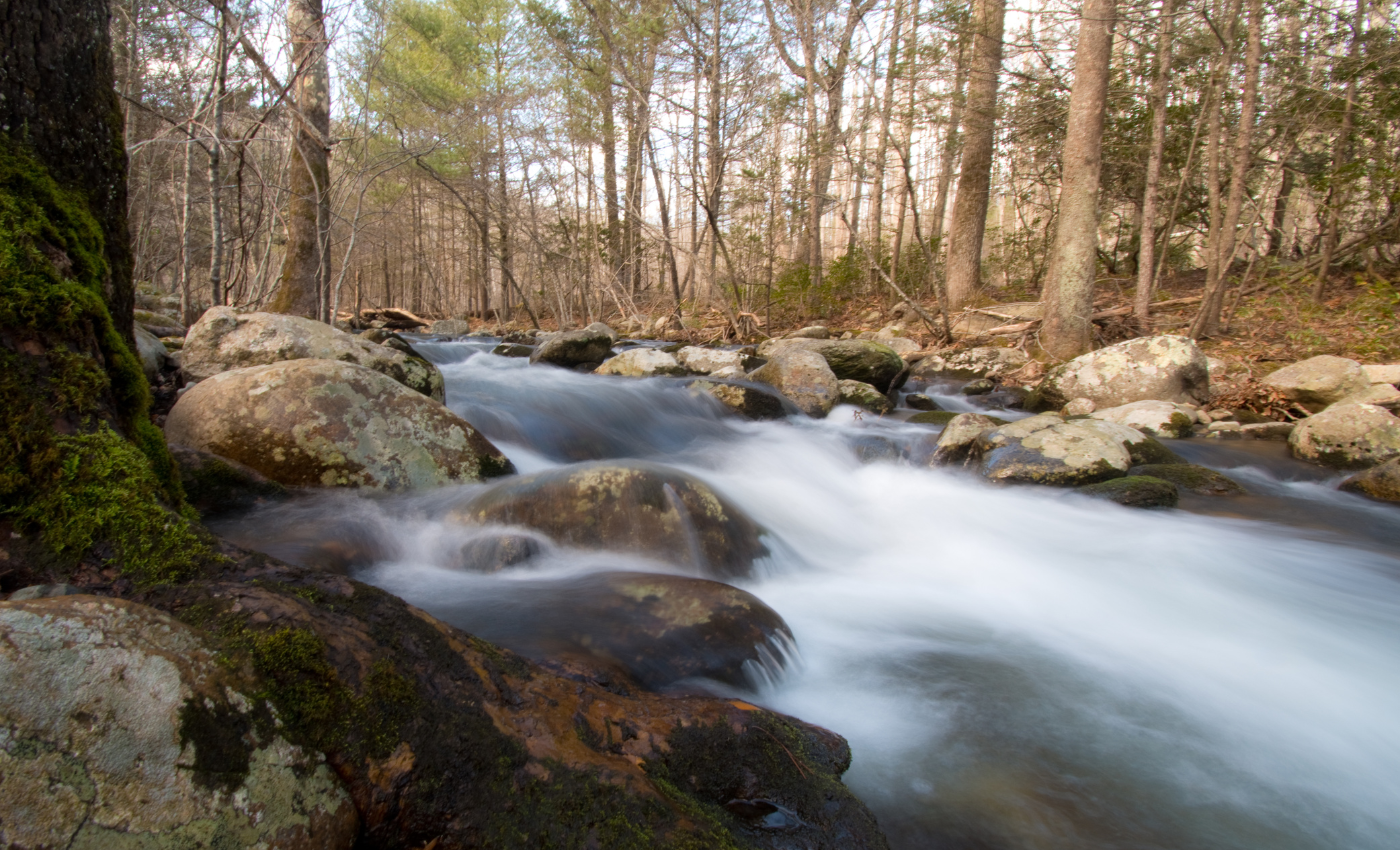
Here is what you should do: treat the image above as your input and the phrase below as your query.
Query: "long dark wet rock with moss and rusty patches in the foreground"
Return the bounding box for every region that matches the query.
[68,548,888,850]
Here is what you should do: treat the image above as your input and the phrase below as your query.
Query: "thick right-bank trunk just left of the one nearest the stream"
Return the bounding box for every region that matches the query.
[944,0,1008,311]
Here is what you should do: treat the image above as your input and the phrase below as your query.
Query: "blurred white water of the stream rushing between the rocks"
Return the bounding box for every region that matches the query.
[215,342,1400,850]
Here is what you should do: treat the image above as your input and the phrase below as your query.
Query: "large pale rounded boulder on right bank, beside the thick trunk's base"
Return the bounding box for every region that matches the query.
[1026,336,1210,410]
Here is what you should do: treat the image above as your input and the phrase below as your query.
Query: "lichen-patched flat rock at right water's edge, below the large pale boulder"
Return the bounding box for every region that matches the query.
[974,413,1141,487]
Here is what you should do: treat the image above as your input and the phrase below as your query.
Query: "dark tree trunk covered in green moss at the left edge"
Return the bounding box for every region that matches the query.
[0,0,211,591]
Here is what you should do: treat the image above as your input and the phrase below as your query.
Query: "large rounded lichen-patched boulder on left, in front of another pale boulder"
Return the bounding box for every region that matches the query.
[165,360,514,490]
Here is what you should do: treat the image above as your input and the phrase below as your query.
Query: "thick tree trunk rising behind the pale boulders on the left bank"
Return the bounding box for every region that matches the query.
[269,0,330,318]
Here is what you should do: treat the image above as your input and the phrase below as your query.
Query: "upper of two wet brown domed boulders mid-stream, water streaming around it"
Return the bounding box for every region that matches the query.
[448,461,769,578]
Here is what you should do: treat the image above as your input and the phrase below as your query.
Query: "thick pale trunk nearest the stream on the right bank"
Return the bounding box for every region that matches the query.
[1040,0,1116,360]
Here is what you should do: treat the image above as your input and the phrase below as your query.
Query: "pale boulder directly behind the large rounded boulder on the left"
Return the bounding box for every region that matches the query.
[181,307,445,402]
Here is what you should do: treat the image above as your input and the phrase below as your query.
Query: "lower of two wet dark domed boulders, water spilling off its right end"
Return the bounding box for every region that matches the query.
[461,571,792,689]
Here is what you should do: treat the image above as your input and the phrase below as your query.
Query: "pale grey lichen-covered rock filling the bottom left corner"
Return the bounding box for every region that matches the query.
[0,595,357,850]
